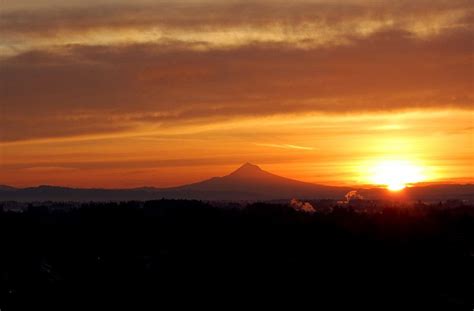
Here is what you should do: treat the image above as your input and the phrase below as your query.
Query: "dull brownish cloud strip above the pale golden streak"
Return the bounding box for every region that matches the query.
[0,0,473,35]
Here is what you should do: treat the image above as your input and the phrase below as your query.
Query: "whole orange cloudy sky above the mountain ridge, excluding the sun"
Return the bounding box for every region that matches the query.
[0,0,474,188]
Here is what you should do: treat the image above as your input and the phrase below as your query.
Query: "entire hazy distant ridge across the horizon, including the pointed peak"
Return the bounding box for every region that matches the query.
[0,163,474,202]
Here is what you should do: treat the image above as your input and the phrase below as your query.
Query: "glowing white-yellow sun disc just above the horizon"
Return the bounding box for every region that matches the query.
[371,160,425,191]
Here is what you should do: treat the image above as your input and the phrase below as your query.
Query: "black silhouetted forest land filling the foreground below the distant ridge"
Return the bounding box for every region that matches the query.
[0,200,474,311]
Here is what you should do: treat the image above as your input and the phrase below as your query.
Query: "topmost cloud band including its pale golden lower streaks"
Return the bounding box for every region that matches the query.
[0,0,473,53]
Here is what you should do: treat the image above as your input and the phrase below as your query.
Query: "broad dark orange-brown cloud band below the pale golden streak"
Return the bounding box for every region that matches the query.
[0,32,473,141]
